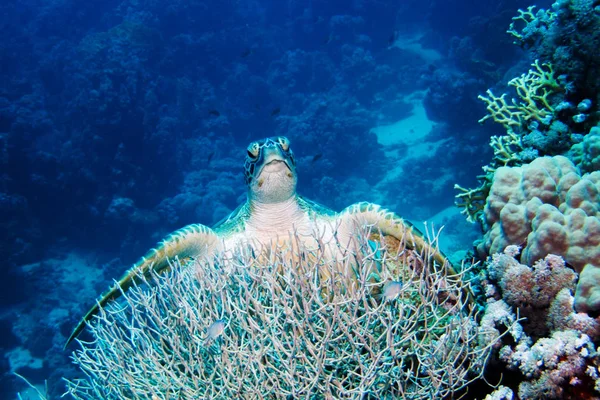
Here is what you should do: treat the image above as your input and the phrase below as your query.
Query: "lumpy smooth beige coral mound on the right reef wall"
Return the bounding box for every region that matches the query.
[478,156,600,311]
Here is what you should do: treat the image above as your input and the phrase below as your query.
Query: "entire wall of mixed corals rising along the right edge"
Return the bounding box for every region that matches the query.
[456,0,600,400]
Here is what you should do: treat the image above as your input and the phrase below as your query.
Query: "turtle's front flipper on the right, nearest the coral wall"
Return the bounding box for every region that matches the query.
[340,202,455,274]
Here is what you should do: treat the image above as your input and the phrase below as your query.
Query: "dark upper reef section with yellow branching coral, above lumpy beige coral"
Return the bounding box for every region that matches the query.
[455,0,600,222]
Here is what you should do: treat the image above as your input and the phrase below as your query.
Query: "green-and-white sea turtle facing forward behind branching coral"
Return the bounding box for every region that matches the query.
[66,136,453,345]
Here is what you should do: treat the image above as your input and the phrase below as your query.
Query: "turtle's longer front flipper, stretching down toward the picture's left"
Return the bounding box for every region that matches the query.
[65,224,219,348]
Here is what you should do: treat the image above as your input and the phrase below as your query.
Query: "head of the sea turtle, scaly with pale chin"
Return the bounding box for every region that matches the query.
[244,136,298,203]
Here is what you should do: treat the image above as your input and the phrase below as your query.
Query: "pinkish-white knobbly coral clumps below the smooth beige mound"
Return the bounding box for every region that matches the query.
[487,246,600,399]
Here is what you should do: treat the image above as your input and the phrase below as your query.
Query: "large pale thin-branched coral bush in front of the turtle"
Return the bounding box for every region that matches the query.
[68,230,501,399]
